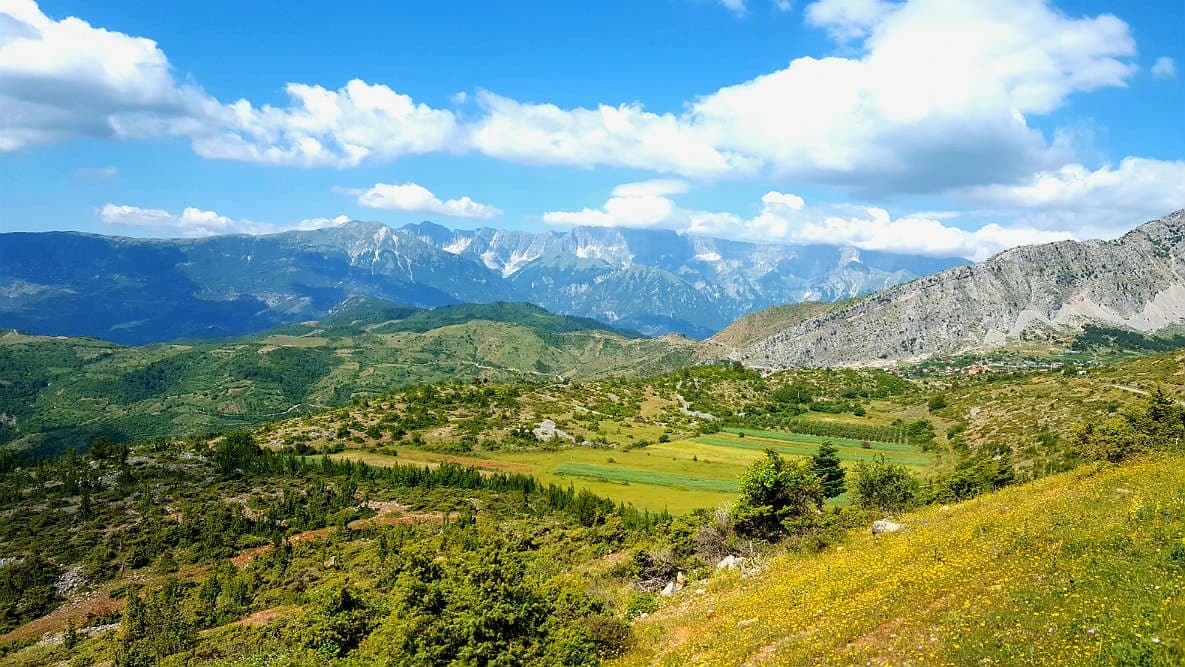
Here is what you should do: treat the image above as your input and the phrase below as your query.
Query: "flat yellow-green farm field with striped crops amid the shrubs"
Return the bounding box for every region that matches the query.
[333,429,933,514]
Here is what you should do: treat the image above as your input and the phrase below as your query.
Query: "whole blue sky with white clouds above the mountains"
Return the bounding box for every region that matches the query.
[0,0,1185,259]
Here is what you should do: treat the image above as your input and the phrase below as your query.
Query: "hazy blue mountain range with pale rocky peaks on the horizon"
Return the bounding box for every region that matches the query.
[0,222,963,344]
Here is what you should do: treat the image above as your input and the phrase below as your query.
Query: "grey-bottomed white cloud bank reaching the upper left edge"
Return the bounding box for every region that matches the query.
[0,0,461,167]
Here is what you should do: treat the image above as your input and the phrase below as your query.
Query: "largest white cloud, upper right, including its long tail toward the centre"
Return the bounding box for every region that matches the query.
[470,0,1135,194]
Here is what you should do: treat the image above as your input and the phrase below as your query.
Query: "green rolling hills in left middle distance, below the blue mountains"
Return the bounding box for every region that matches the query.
[0,297,700,453]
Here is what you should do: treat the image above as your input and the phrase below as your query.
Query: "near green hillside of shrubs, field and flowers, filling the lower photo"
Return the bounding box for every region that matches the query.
[0,343,1185,667]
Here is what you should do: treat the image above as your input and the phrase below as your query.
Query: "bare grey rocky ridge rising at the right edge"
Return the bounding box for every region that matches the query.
[734,210,1185,368]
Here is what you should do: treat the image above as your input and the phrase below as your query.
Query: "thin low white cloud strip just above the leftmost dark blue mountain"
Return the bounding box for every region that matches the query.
[98,204,348,237]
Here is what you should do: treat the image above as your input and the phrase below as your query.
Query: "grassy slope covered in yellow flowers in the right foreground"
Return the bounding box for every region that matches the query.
[620,455,1185,666]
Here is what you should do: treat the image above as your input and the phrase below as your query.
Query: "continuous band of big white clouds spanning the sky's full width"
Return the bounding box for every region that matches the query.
[0,0,1171,210]
